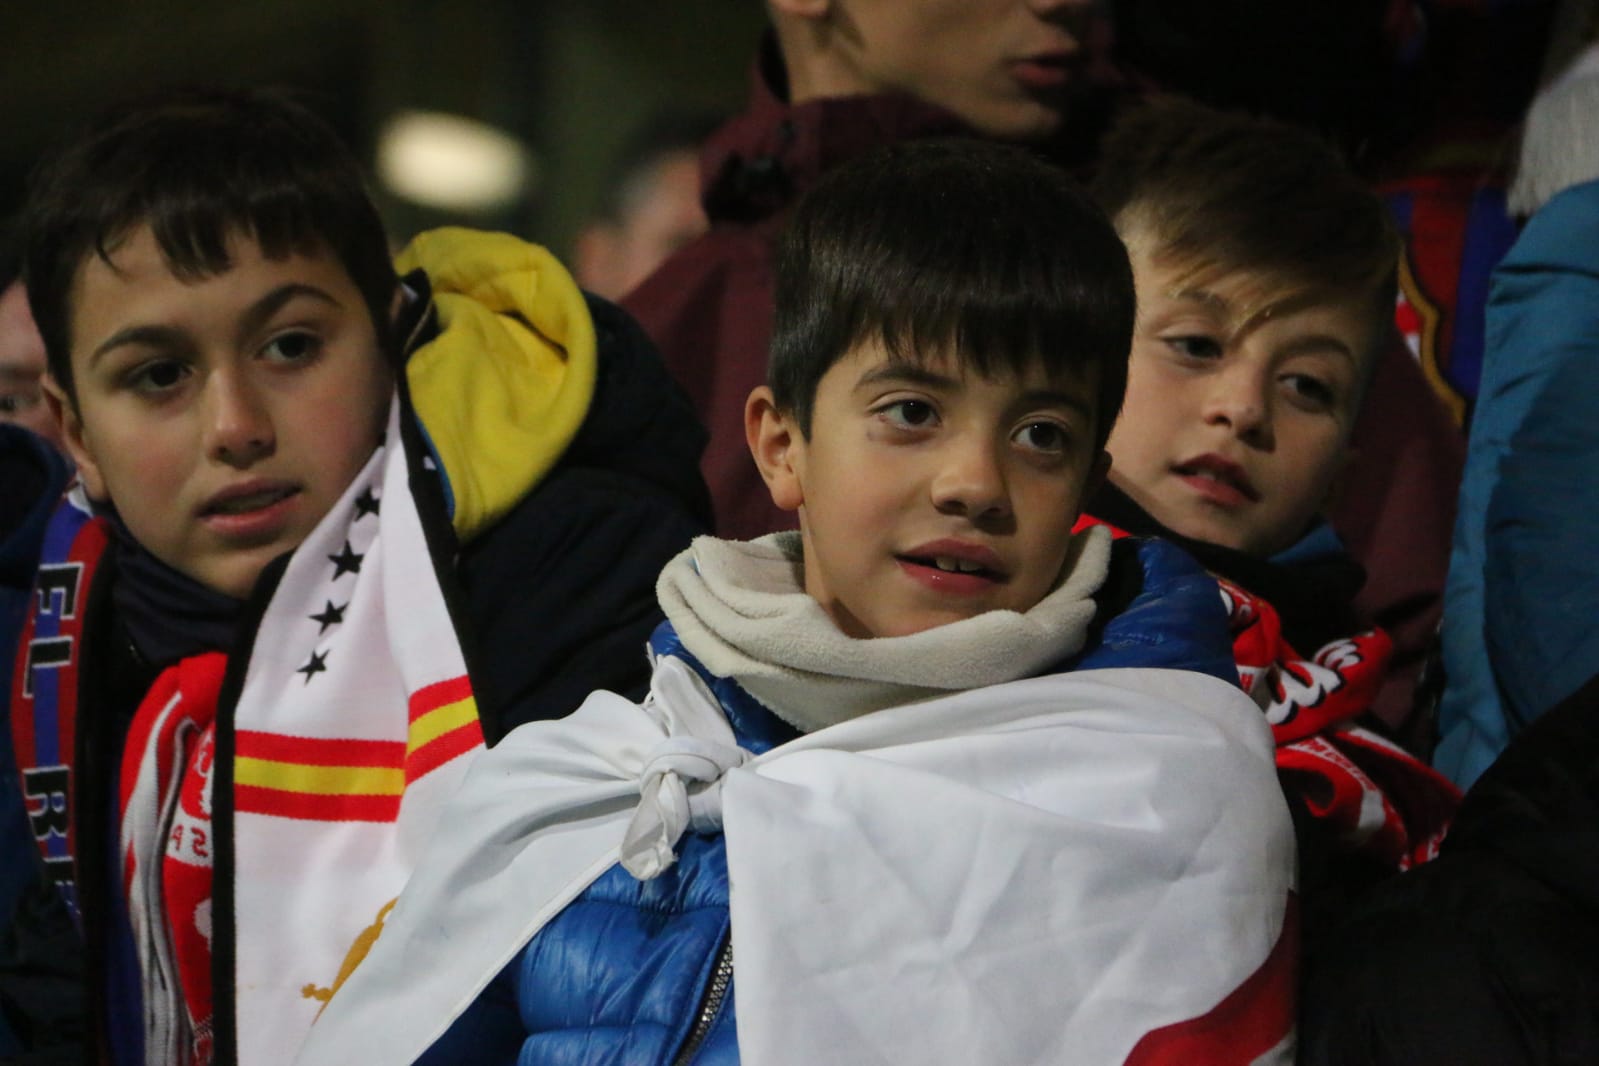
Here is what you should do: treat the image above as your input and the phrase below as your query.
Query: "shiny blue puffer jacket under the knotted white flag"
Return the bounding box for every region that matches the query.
[419,539,1238,1066]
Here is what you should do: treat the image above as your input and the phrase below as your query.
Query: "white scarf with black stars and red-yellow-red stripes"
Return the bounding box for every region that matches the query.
[221,401,483,1066]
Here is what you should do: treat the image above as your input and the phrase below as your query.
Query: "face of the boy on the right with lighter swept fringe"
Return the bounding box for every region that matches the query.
[1107,227,1377,558]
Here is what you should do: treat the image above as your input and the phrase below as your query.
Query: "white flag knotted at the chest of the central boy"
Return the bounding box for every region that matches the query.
[299,658,1294,1066]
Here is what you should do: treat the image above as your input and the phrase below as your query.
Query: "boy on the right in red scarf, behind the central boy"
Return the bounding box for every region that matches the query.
[1087,99,1458,946]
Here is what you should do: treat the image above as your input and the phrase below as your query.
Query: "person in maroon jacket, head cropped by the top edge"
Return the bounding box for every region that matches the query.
[624,0,1118,539]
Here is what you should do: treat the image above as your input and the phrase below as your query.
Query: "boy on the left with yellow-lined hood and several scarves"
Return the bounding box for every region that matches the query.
[13,89,704,1064]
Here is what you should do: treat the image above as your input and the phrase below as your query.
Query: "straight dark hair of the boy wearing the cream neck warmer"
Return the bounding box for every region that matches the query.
[768,139,1135,447]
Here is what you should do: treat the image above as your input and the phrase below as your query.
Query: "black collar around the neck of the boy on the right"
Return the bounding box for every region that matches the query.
[1086,483,1366,655]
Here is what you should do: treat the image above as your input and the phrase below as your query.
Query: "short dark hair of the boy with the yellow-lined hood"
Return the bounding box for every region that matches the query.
[22,88,397,396]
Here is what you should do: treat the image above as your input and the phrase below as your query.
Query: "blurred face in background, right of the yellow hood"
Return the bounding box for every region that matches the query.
[574,149,708,300]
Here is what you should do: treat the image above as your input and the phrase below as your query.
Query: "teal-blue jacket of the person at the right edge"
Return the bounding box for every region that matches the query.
[1434,182,1599,786]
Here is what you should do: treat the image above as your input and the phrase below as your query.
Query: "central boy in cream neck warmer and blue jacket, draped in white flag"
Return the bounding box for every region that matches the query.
[301,141,1292,1066]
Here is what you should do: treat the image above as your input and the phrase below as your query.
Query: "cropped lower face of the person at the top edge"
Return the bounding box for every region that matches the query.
[772,0,1108,141]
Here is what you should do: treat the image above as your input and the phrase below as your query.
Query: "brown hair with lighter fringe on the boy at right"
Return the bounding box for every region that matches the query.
[1092,97,1401,369]
